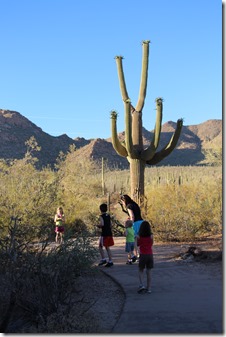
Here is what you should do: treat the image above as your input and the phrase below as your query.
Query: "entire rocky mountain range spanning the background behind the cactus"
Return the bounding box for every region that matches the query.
[0,109,222,169]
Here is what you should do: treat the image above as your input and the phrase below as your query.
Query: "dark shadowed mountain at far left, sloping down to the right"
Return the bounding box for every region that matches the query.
[0,109,89,166]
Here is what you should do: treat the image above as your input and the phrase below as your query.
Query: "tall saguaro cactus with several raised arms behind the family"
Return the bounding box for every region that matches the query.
[111,41,183,204]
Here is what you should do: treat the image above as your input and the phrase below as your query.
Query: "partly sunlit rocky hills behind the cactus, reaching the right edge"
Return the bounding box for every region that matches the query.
[75,120,222,168]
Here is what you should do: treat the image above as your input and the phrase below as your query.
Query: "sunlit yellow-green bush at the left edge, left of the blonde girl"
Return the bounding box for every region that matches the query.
[0,160,56,231]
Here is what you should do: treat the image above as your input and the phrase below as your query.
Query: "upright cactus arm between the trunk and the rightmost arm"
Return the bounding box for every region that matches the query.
[141,97,163,161]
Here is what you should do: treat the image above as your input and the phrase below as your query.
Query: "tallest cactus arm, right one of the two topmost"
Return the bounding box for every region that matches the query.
[136,40,150,111]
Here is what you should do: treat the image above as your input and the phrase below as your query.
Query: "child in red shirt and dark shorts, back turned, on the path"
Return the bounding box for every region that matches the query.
[137,221,154,294]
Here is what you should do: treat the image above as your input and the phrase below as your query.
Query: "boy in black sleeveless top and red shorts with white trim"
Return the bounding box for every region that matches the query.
[96,204,114,267]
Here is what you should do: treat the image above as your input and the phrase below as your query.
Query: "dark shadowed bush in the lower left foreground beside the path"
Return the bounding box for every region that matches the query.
[0,218,98,332]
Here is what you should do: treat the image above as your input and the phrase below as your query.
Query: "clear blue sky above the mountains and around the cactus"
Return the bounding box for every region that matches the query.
[0,0,222,139]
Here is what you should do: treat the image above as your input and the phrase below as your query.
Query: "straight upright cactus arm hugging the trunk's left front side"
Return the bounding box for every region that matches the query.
[125,99,135,158]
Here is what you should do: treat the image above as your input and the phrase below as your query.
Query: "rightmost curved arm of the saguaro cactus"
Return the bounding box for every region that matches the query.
[146,119,183,165]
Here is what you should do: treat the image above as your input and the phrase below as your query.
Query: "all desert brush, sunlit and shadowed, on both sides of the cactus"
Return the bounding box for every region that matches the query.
[0,144,222,332]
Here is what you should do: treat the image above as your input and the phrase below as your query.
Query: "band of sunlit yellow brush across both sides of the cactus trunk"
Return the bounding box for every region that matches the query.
[0,147,222,240]
